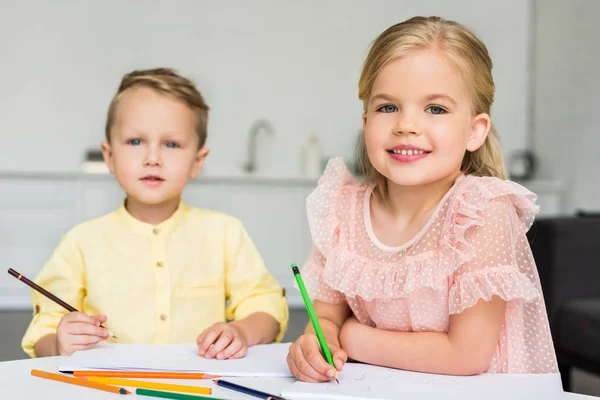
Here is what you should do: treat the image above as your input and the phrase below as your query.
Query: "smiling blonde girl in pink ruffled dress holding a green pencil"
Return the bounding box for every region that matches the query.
[287,17,557,382]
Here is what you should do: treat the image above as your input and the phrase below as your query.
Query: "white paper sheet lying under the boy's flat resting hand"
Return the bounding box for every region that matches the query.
[59,343,292,378]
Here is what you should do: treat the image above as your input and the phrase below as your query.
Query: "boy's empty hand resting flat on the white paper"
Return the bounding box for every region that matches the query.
[196,322,248,360]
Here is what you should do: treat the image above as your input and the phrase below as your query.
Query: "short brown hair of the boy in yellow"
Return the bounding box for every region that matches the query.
[105,68,209,148]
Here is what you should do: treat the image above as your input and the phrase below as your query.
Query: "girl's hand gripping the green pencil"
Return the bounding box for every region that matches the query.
[286,333,348,382]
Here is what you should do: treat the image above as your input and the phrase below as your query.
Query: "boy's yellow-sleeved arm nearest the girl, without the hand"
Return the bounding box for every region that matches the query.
[225,218,289,346]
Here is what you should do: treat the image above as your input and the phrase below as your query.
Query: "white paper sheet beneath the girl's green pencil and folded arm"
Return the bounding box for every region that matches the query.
[282,364,562,400]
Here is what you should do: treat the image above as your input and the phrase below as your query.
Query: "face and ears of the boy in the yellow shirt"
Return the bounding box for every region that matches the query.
[102,87,208,205]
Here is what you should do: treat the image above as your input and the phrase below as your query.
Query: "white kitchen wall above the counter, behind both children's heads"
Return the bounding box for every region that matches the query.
[0,0,532,175]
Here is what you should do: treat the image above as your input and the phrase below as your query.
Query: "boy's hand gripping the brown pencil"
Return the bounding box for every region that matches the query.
[56,312,108,356]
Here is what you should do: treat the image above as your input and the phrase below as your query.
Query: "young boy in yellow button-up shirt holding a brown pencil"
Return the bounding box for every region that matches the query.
[22,69,288,359]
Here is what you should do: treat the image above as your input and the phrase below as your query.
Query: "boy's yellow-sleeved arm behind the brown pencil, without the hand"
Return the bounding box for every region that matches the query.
[21,233,85,357]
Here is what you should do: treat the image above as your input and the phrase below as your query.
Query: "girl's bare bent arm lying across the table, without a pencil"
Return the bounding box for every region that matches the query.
[340,296,506,375]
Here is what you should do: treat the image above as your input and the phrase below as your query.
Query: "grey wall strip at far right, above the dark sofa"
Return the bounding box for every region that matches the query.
[533,0,600,211]
